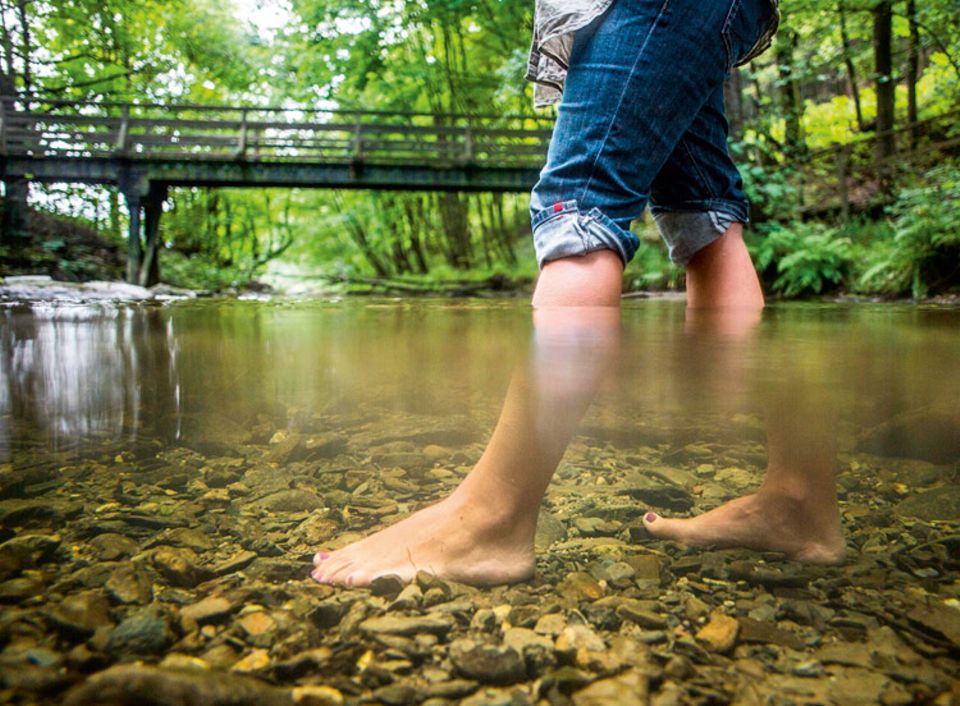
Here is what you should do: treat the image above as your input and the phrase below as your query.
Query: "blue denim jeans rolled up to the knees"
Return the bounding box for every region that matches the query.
[530,0,774,267]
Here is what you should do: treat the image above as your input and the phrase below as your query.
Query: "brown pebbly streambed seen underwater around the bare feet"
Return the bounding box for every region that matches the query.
[0,415,960,706]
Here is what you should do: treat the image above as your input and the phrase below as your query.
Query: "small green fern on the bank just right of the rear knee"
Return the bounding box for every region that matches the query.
[748,223,854,298]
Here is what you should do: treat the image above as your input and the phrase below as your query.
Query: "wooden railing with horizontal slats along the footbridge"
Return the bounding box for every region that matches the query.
[0,101,552,167]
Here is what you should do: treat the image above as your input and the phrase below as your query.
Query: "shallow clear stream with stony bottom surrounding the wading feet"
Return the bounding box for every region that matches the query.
[0,300,960,706]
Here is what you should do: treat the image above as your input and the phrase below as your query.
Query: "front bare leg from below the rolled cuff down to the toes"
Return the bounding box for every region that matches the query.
[312,250,623,586]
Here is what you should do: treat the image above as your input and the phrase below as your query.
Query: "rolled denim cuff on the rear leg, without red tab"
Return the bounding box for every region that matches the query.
[650,201,749,266]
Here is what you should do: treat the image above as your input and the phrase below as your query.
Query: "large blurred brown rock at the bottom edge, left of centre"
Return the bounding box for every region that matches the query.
[65,665,290,706]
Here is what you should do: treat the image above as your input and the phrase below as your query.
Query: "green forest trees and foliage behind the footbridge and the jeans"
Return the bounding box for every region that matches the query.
[0,0,960,297]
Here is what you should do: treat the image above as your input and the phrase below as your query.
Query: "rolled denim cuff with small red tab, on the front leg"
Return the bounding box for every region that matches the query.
[531,200,640,269]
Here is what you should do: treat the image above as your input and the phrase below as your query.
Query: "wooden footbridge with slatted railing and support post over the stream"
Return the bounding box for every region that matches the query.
[0,97,552,284]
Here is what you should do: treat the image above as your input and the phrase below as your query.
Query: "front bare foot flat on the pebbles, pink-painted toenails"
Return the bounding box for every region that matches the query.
[310,486,536,586]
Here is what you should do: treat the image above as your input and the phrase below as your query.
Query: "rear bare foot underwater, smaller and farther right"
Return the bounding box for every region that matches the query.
[643,489,846,564]
